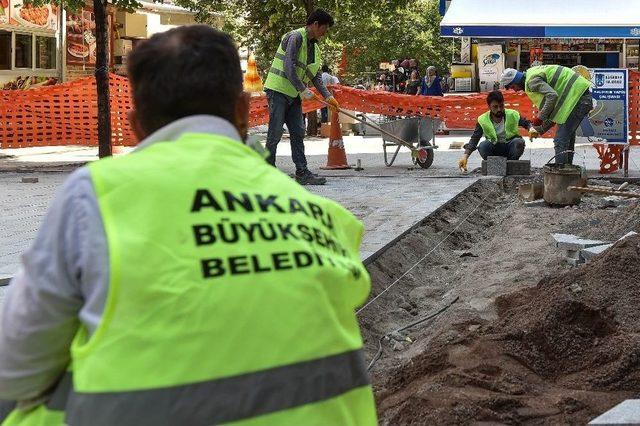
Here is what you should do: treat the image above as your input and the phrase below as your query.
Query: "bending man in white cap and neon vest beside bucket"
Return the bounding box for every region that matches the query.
[500,65,593,164]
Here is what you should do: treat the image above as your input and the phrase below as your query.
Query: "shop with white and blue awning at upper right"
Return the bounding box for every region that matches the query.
[441,0,640,89]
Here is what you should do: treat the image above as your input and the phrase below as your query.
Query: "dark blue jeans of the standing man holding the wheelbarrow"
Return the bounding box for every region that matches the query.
[265,89,307,172]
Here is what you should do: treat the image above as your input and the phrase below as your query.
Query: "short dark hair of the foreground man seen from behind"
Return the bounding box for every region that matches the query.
[128,25,243,133]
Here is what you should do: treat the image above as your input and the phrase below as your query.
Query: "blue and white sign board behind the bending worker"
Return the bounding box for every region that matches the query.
[583,68,629,144]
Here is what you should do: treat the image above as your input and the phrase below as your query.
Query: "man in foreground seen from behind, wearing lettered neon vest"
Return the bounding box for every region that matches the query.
[0,25,376,426]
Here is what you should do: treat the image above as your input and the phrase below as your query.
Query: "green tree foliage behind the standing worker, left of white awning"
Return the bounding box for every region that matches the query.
[185,0,453,83]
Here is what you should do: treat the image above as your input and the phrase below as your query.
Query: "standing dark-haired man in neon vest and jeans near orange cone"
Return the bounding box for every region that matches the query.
[264,9,338,185]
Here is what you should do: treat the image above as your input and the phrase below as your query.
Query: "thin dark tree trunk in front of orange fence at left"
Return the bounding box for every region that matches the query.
[93,0,111,158]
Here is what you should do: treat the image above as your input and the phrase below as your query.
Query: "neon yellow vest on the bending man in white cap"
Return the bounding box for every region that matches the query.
[525,65,591,124]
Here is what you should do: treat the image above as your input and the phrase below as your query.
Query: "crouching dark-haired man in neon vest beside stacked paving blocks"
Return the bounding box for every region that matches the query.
[458,90,538,171]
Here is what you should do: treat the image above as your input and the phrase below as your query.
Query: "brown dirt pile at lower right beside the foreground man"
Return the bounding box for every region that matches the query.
[378,236,640,424]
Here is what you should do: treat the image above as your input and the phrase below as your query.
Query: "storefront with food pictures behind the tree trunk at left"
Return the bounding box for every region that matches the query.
[0,0,195,89]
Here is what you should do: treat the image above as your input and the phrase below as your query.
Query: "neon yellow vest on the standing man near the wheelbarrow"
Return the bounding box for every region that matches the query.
[264,28,322,98]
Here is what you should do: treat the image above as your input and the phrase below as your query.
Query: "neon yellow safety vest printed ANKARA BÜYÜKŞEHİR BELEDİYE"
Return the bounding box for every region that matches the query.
[67,133,376,426]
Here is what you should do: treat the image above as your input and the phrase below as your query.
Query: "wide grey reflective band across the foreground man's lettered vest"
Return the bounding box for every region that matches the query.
[67,350,369,426]
